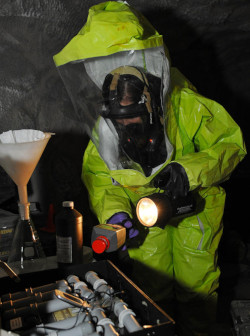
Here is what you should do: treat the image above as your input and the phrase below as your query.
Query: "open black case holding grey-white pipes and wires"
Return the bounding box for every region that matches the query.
[0,261,174,336]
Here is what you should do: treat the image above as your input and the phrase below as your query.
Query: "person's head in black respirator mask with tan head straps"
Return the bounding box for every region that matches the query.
[102,66,163,176]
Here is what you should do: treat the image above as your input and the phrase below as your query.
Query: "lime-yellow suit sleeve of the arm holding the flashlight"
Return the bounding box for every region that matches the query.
[167,69,246,190]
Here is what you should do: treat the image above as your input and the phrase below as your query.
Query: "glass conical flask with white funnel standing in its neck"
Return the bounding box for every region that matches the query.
[0,129,52,268]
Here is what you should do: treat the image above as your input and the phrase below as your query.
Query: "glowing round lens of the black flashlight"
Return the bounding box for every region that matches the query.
[136,198,158,227]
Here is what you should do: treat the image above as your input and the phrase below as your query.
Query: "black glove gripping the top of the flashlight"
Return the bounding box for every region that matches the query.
[154,162,189,199]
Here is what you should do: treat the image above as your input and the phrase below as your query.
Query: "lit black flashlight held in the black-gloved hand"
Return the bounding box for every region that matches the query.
[136,193,195,228]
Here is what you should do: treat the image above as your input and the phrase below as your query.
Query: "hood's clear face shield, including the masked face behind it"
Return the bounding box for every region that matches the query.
[55,47,169,174]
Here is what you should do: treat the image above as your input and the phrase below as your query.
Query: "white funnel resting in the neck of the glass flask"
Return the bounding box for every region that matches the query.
[0,130,52,219]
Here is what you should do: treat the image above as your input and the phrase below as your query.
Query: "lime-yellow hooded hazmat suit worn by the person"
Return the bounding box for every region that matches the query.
[54,1,246,335]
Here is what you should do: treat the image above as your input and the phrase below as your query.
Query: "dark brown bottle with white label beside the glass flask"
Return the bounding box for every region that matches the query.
[55,201,83,267]
